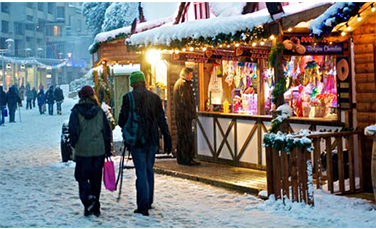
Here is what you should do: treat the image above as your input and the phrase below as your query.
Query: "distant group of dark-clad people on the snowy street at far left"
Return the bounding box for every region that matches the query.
[0,84,64,125]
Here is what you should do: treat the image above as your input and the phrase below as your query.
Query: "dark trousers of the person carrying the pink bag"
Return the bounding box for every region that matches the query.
[74,155,104,211]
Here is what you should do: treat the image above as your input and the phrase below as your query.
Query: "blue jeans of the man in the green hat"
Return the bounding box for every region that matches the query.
[131,146,158,210]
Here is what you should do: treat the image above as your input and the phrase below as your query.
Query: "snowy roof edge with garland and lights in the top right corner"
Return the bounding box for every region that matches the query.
[309,2,368,38]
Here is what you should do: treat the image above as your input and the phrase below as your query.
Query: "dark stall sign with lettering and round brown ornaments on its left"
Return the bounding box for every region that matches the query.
[283,35,344,55]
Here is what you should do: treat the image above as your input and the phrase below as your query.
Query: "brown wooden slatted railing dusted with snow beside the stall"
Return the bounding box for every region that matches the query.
[266,131,363,205]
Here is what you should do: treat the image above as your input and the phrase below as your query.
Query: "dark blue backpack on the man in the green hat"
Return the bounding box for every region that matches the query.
[123,92,145,147]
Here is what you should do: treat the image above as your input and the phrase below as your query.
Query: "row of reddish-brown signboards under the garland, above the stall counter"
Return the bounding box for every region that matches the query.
[171,47,270,64]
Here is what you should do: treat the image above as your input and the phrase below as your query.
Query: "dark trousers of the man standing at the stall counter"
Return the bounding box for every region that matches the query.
[176,119,194,165]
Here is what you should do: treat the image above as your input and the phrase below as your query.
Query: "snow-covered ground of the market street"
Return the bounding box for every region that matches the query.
[0,87,376,227]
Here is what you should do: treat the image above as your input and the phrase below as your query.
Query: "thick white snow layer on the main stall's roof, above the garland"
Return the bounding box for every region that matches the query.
[127,2,328,46]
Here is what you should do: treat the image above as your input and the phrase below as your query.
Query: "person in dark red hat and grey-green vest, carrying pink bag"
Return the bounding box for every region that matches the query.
[69,86,111,217]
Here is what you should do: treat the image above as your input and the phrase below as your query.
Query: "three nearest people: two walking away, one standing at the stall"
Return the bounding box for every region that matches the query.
[69,68,199,216]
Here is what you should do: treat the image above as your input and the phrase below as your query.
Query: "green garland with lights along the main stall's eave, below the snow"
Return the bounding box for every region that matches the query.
[127,27,266,51]
